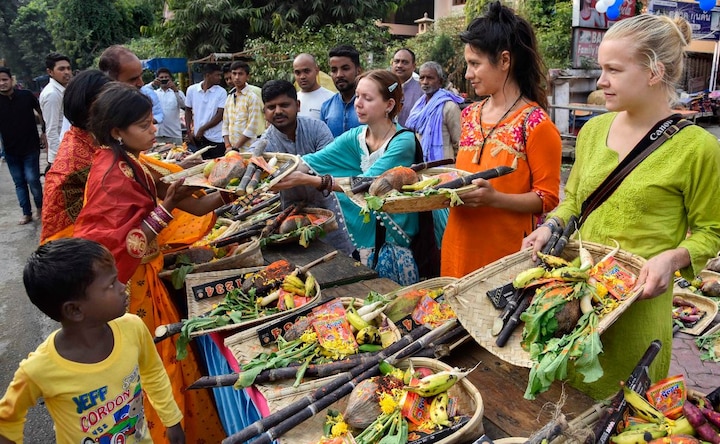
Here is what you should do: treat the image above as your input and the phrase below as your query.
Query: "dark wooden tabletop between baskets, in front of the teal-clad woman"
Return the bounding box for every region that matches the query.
[263,241,377,288]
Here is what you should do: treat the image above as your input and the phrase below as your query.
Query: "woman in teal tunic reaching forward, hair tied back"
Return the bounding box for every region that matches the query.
[275,69,418,270]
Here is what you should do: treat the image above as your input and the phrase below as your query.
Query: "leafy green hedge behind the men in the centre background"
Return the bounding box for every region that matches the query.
[245,19,391,85]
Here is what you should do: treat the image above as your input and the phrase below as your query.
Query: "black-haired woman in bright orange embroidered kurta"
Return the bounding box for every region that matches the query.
[441,2,562,277]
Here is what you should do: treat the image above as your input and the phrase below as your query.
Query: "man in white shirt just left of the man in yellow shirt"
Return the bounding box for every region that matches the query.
[185,63,227,159]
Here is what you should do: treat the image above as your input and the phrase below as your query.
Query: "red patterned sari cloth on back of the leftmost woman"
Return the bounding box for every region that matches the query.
[40,126,98,244]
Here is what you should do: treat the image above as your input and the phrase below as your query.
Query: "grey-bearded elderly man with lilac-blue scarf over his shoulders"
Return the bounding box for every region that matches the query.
[405,62,463,161]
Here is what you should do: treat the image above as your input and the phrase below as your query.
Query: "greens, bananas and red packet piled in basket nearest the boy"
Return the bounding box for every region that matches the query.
[174,259,317,359]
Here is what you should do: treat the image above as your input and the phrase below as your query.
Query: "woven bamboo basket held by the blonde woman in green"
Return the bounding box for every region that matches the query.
[445,241,645,368]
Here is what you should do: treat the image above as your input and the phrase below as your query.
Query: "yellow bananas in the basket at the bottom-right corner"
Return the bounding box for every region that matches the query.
[610,387,695,444]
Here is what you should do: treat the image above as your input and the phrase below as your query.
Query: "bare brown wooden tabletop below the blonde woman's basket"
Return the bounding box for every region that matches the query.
[443,341,594,438]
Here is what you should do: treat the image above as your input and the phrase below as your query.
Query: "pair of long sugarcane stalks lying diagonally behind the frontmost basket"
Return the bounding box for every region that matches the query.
[223,322,457,444]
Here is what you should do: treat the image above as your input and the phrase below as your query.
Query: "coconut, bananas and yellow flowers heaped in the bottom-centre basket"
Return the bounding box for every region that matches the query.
[319,361,474,444]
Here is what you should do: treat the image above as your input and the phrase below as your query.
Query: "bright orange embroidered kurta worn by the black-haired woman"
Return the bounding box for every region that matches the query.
[441,103,562,277]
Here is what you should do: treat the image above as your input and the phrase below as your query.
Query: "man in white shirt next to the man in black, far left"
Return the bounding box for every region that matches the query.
[39,52,72,172]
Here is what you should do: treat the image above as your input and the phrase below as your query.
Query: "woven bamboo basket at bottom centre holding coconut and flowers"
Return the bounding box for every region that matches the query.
[271,358,484,444]
